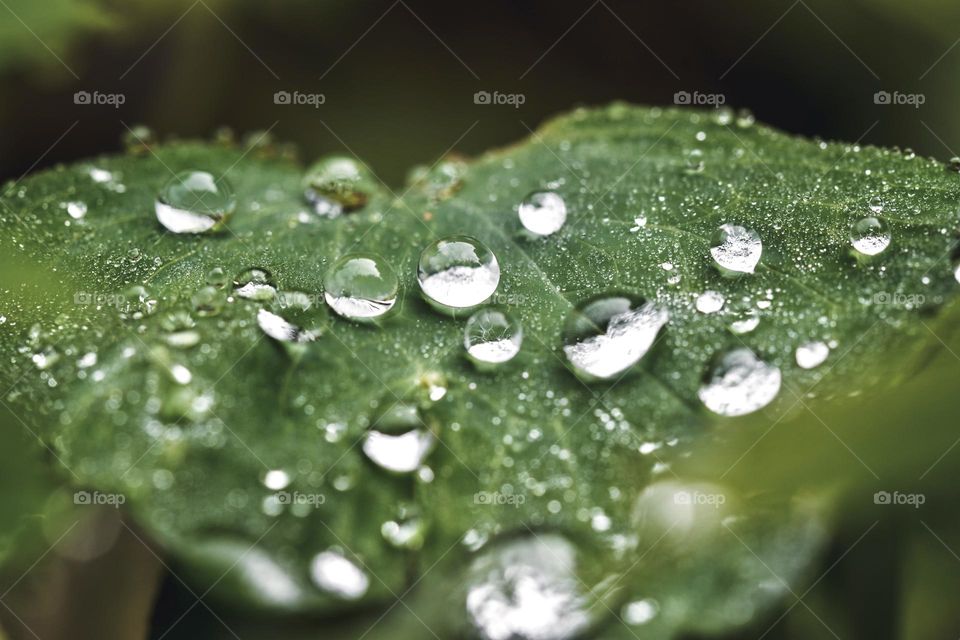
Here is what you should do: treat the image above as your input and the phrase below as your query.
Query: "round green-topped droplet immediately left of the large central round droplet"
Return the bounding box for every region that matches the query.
[323,253,400,322]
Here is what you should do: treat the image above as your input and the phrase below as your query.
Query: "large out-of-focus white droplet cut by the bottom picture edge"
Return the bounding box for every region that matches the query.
[465,533,593,640]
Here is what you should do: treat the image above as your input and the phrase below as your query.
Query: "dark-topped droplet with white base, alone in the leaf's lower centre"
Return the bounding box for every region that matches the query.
[363,402,437,473]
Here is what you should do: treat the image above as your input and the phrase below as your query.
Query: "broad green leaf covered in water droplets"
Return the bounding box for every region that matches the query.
[0,104,960,637]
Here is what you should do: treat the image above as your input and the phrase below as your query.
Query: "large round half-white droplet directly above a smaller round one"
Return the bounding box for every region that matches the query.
[417,236,500,311]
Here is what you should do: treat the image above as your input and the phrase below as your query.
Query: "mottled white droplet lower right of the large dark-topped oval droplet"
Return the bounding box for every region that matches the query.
[697,348,780,416]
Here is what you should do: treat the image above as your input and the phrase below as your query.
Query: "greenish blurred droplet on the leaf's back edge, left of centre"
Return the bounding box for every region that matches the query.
[303,156,377,211]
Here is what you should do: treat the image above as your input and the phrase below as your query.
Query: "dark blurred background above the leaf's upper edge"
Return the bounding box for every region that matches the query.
[0,0,960,185]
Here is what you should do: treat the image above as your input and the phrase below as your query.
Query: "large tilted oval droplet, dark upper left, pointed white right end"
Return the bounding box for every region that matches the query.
[563,296,670,380]
